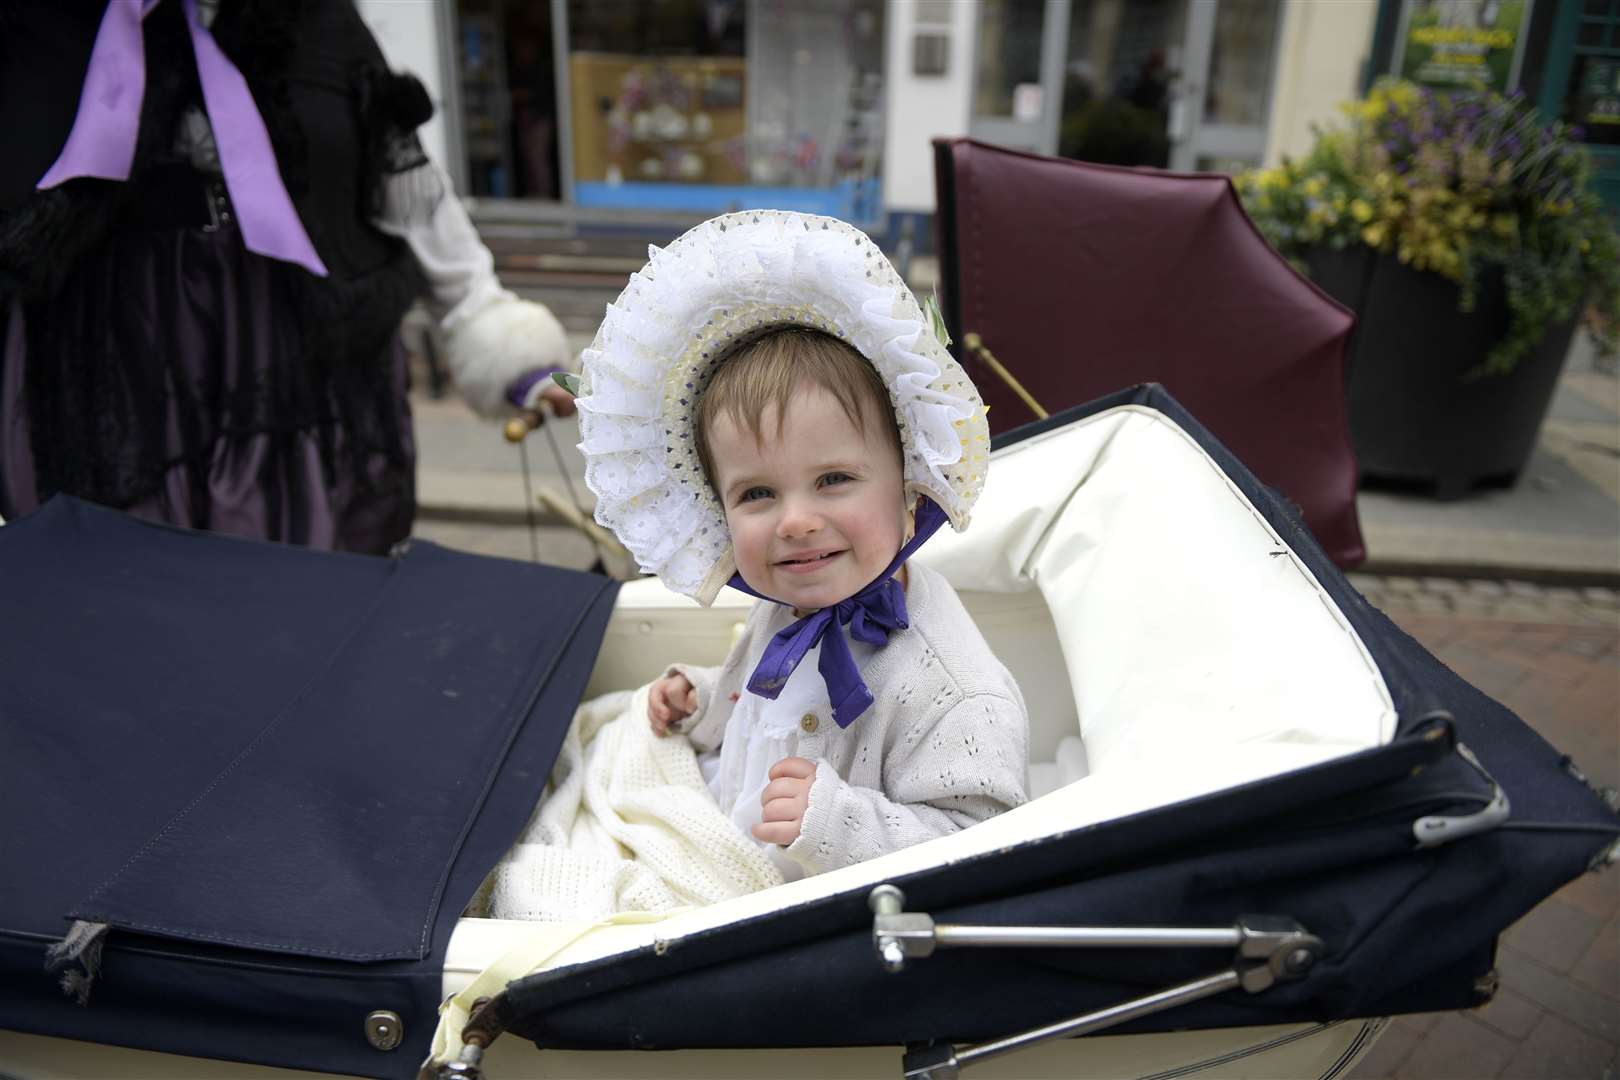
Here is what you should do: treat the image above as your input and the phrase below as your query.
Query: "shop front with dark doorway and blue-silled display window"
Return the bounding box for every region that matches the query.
[446,0,885,222]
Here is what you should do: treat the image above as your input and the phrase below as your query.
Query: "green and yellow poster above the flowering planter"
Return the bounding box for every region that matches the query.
[1395,0,1531,94]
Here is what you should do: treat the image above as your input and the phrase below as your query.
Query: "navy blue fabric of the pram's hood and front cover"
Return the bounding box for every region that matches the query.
[0,385,1620,1077]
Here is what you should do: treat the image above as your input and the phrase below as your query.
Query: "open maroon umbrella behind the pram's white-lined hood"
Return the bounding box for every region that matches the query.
[933,139,1366,567]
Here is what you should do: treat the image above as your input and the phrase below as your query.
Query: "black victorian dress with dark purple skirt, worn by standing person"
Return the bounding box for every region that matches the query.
[0,0,442,552]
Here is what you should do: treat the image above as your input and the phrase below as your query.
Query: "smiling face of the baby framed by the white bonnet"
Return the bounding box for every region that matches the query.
[708,385,906,609]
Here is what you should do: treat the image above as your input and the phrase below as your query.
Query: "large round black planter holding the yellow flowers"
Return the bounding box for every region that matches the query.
[1309,248,1575,499]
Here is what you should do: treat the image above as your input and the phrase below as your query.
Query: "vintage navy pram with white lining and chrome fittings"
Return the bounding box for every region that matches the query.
[0,385,1620,1078]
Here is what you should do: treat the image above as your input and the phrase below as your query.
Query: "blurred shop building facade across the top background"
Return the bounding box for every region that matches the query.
[360,0,1620,227]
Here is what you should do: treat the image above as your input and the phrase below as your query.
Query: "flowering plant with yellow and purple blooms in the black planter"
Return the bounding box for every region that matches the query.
[1234,79,1620,372]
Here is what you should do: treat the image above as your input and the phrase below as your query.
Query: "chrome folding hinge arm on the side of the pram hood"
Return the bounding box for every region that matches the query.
[867,884,1322,1080]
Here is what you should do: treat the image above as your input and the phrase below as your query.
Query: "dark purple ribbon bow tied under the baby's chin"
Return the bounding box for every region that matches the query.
[731,499,944,727]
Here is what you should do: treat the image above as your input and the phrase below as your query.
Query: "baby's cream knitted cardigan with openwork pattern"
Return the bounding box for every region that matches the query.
[669,563,1029,874]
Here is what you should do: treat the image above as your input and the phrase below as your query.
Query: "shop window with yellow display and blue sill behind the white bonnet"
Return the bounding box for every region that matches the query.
[569,0,883,220]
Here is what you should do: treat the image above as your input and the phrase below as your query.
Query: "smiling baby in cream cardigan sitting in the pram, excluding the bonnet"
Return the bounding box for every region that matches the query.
[648,327,1029,879]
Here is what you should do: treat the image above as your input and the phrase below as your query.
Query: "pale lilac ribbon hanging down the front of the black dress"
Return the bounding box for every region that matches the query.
[36,0,326,277]
